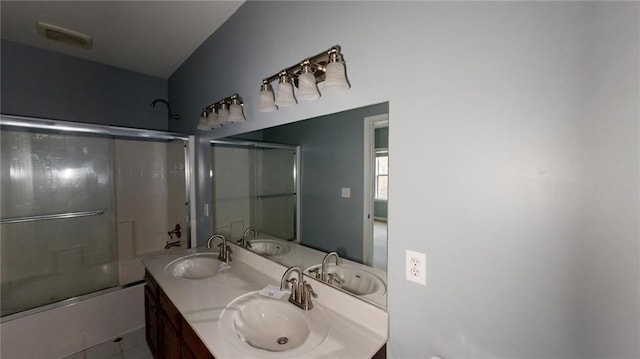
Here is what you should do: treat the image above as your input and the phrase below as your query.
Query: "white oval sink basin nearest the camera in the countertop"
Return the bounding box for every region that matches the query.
[219,292,329,358]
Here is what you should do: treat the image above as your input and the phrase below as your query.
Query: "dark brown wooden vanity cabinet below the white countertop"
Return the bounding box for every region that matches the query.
[144,272,214,359]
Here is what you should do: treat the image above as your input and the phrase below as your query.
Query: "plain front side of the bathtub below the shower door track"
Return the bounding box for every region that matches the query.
[0,283,144,359]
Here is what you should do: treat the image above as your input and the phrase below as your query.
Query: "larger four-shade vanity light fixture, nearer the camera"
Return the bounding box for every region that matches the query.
[258,45,350,112]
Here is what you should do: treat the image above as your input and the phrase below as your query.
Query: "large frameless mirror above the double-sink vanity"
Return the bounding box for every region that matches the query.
[211,103,389,307]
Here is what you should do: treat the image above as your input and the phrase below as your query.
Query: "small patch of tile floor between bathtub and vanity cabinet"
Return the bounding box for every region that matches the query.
[63,327,153,359]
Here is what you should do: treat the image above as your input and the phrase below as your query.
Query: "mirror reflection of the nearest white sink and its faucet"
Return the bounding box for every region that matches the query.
[304,264,387,298]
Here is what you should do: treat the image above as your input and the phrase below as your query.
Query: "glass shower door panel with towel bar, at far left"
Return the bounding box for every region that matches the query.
[0,128,118,316]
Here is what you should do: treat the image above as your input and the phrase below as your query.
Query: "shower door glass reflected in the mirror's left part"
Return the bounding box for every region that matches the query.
[211,142,297,240]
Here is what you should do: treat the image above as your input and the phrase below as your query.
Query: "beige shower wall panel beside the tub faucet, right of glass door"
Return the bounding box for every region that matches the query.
[115,139,188,284]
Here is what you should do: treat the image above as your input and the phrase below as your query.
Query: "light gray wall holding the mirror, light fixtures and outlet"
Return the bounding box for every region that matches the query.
[169,2,640,358]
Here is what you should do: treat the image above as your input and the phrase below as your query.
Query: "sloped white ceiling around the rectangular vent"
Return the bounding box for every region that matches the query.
[0,0,244,79]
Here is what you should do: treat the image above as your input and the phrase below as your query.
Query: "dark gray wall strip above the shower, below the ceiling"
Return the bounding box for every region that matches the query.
[0,40,169,130]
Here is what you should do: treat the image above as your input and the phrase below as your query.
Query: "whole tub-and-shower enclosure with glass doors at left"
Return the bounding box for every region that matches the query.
[1,116,189,358]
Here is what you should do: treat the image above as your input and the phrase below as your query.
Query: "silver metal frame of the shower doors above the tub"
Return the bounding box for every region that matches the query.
[0,114,193,323]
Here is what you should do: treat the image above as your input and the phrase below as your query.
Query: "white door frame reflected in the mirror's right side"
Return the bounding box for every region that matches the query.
[362,113,389,266]
